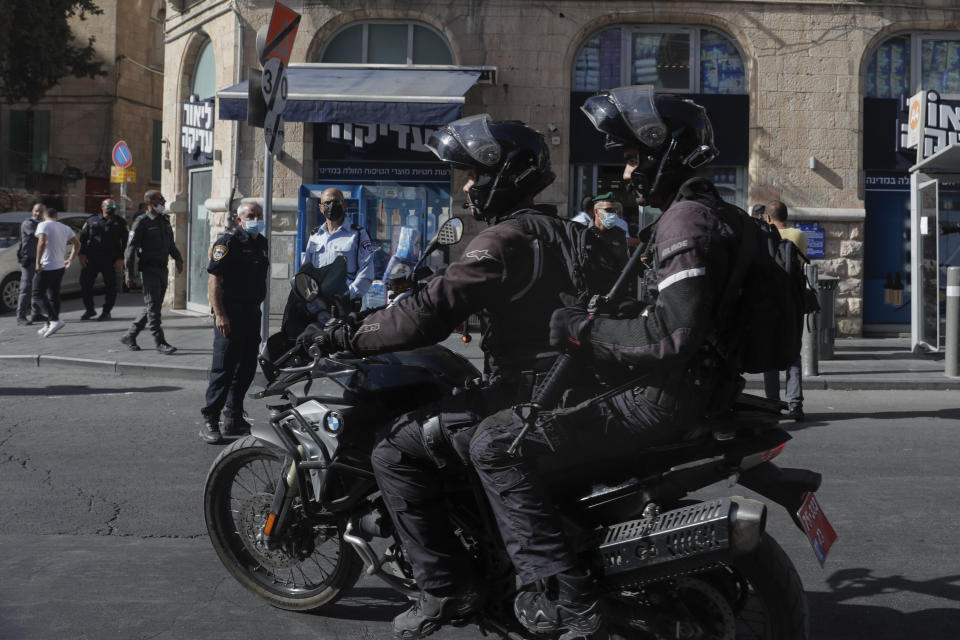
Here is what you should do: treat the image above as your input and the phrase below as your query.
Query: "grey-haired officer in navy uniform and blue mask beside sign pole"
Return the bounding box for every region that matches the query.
[200,202,270,444]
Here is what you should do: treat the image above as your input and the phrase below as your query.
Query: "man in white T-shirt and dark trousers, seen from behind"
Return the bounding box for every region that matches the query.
[33,209,80,338]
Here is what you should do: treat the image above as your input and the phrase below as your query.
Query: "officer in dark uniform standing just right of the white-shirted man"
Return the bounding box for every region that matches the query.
[80,198,127,320]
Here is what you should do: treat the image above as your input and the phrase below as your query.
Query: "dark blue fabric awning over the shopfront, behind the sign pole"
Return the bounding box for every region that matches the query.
[217,63,495,125]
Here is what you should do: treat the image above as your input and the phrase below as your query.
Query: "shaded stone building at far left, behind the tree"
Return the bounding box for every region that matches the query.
[0,0,166,219]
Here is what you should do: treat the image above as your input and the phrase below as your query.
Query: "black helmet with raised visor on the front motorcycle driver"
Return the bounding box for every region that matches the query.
[426,113,556,220]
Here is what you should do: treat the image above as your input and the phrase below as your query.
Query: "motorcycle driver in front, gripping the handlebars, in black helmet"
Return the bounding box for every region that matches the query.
[318,114,579,639]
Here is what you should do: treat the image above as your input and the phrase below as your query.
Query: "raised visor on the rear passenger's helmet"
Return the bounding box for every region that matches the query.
[580,85,667,149]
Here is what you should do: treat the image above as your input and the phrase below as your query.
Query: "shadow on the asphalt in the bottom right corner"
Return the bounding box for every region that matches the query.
[807,568,960,640]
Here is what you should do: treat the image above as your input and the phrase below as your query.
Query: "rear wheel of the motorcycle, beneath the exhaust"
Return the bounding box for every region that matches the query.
[607,536,809,640]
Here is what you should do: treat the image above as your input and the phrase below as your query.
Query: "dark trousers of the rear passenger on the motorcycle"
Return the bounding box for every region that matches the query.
[470,388,683,584]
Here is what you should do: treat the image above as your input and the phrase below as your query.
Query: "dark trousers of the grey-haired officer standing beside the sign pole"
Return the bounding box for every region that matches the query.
[201,307,260,417]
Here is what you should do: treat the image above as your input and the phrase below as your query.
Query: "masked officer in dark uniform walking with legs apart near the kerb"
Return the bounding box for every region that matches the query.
[120,190,183,355]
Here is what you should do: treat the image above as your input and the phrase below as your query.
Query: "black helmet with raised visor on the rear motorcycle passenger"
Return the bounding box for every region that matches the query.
[580,85,719,207]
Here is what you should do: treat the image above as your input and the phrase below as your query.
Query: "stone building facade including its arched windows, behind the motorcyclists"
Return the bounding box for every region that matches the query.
[162,0,960,335]
